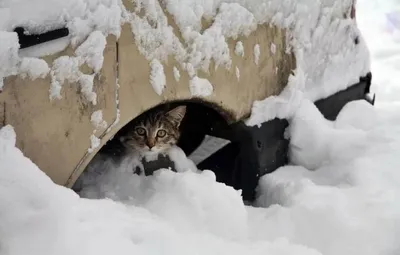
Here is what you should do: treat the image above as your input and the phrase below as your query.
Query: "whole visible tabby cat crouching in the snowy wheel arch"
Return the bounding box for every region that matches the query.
[120,105,186,175]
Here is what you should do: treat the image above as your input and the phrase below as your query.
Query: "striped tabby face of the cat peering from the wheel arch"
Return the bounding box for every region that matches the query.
[121,106,186,153]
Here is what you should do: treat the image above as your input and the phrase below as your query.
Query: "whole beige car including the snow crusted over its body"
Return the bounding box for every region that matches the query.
[0,0,375,200]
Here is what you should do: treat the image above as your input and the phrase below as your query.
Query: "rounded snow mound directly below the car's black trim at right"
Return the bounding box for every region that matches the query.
[288,100,374,169]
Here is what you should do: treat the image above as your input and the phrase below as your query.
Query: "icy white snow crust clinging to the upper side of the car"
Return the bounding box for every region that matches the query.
[0,0,369,116]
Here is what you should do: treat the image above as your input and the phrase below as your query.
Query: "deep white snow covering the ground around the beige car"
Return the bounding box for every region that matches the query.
[0,0,400,255]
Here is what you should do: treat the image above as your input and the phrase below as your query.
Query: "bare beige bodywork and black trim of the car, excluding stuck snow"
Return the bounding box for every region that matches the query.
[0,0,371,199]
